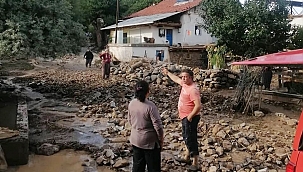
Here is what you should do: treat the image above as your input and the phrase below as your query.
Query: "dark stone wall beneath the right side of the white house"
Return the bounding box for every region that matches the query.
[169,47,208,69]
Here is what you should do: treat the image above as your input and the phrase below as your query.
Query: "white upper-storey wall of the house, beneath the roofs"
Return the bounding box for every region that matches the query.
[111,6,216,45]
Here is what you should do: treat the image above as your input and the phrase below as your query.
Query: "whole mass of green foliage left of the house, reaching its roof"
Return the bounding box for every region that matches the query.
[0,0,164,58]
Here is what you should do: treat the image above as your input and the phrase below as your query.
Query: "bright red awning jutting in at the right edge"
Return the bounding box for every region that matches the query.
[232,49,303,66]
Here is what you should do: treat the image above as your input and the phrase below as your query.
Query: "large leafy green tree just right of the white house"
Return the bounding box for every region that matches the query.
[201,0,290,58]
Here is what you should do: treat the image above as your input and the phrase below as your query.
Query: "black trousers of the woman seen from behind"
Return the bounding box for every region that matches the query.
[132,145,161,172]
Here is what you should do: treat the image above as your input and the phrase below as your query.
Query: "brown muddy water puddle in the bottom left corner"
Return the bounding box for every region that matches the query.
[7,150,114,172]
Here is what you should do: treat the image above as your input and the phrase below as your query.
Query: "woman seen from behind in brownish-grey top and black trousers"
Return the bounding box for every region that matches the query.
[128,81,164,172]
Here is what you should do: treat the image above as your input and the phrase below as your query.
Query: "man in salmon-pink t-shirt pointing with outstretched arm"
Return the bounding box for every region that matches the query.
[162,68,201,171]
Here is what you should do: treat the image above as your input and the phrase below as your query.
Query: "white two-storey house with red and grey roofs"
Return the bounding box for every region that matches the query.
[101,0,215,61]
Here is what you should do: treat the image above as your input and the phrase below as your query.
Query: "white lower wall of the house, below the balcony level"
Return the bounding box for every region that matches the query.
[108,44,169,61]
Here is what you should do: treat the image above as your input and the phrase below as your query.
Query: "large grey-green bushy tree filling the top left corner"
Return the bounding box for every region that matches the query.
[0,0,85,57]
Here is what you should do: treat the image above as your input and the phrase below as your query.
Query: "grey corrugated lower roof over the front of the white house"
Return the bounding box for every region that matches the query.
[101,12,180,30]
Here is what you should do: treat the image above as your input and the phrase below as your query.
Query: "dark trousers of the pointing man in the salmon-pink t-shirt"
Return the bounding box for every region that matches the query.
[182,115,200,157]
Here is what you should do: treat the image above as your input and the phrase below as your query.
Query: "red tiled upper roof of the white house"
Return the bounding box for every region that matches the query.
[127,0,202,18]
